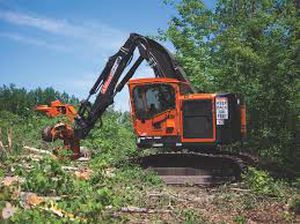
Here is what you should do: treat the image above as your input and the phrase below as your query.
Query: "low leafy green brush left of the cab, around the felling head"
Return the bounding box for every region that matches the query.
[0,110,168,223]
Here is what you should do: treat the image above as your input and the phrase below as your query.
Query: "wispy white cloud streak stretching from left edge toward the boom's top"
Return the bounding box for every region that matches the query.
[0,10,128,51]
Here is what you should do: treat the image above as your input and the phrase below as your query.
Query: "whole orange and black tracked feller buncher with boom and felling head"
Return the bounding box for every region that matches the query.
[39,33,247,184]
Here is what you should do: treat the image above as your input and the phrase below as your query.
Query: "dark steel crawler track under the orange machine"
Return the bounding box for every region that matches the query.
[135,151,255,186]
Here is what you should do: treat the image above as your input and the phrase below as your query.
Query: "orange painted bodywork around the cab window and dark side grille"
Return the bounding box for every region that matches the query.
[129,78,216,143]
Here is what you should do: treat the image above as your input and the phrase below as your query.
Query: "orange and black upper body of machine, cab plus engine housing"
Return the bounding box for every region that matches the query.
[129,78,242,148]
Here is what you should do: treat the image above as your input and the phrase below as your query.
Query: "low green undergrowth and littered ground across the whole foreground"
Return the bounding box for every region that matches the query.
[0,111,299,223]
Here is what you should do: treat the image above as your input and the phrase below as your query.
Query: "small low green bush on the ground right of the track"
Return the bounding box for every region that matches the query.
[243,167,284,197]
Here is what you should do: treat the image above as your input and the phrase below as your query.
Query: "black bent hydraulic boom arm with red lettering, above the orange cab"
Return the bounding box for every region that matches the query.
[73,33,192,139]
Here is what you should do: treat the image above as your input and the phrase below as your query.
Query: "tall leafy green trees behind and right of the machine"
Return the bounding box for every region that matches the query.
[160,0,300,170]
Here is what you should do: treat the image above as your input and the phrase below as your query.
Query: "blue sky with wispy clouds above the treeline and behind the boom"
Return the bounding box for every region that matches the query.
[0,0,215,111]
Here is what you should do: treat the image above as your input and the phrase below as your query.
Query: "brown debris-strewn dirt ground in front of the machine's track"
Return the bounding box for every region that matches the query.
[117,184,300,224]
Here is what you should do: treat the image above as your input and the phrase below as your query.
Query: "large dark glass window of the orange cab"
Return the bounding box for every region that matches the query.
[133,84,175,120]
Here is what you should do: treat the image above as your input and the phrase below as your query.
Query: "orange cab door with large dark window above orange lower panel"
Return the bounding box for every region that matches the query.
[131,83,178,136]
